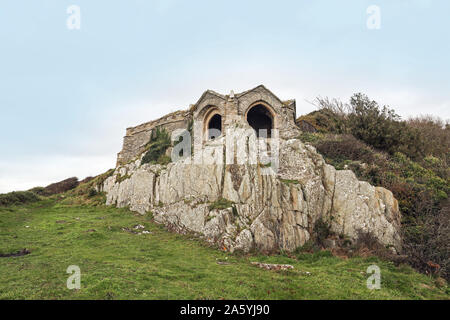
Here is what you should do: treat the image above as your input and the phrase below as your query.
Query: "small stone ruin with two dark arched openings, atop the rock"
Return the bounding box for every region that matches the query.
[117,85,299,165]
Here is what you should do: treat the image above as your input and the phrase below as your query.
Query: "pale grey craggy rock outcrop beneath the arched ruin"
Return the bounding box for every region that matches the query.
[103,139,401,252]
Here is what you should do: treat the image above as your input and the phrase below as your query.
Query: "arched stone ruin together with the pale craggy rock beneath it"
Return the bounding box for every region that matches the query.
[102,85,401,252]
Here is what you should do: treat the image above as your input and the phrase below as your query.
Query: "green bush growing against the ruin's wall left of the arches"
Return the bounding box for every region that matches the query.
[141,128,172,165]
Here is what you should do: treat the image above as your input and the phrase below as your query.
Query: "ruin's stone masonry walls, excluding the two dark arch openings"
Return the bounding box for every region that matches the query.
[117,85,298,165]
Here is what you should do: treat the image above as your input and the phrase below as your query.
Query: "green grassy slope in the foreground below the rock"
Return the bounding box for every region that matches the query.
[0,200,449,299]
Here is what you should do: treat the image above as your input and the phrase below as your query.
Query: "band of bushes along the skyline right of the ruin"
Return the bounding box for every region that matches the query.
[297,93,444,163]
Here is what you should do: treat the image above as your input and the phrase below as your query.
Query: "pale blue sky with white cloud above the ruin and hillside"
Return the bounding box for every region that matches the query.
[0,0,450,192]
